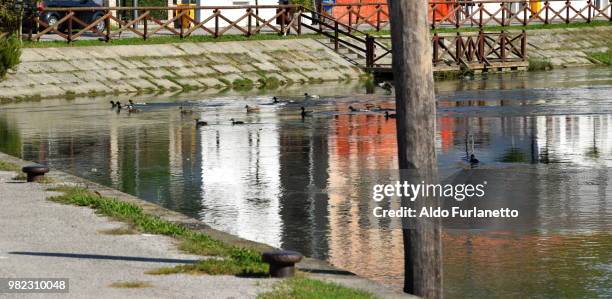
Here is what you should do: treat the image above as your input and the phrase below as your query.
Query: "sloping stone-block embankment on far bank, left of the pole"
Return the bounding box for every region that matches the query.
[0,39,363,99]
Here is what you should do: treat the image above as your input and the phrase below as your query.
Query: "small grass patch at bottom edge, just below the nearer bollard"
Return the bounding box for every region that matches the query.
[258,277,376,299]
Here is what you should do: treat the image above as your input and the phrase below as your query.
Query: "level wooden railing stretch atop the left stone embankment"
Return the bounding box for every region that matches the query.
[29,5,301,42]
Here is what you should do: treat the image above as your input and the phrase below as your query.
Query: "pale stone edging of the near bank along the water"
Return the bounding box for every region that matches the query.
[0,152,418,298]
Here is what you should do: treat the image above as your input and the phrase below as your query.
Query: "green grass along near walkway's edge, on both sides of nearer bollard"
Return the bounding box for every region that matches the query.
[49,187,374,298]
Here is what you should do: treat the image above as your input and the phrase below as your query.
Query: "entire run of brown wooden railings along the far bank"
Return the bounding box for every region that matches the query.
[26,0,612,73]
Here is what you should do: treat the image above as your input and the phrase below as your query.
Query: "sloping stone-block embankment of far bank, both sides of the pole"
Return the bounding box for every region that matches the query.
[0,25,612,103]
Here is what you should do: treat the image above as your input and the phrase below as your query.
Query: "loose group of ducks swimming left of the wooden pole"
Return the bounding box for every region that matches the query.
[110,93,397,128]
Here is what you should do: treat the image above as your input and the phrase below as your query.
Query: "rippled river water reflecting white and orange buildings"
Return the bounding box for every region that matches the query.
[0,68,612,298]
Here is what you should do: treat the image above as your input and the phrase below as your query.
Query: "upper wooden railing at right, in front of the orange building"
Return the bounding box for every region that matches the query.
[318,0,612,31]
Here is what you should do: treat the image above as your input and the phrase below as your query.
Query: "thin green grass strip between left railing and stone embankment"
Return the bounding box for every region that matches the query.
[23,33,321,48]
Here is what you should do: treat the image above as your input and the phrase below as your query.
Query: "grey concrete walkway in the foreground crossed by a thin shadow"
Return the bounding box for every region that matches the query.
[0,171,275,298]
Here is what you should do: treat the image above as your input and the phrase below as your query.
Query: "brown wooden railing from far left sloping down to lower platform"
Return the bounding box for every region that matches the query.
[25,5,526,69]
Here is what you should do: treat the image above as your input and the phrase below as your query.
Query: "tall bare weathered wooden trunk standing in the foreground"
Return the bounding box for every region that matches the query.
[388,0,442,298]
